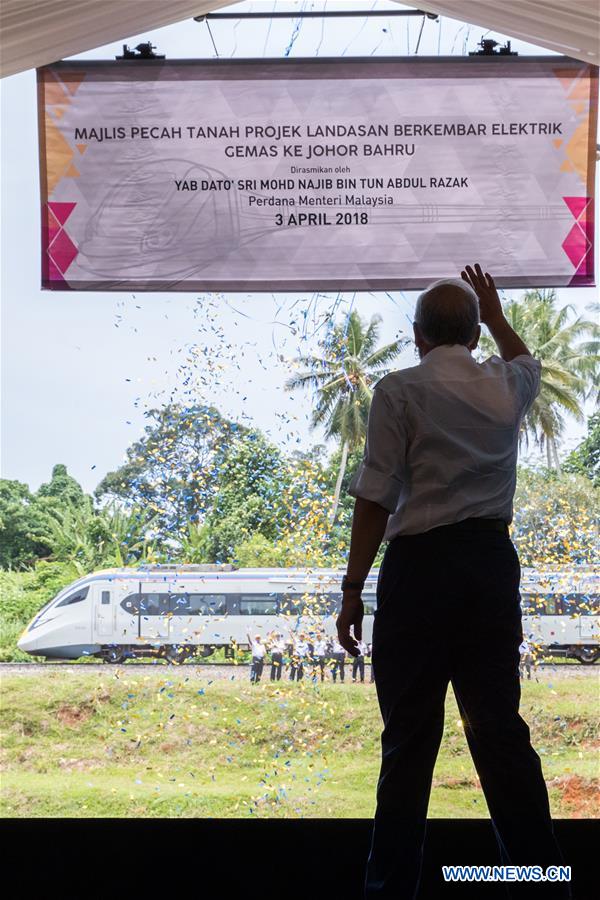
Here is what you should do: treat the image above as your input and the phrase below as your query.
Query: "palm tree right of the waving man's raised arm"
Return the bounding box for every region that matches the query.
[480,290,600,469]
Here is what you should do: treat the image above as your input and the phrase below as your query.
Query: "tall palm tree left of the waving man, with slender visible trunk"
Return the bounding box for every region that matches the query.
[285,312,408,524]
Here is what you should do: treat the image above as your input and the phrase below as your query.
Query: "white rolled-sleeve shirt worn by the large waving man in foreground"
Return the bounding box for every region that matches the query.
[349,344,541,541]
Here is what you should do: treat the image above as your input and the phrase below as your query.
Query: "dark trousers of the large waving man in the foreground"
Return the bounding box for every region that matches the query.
[365,522,570,900]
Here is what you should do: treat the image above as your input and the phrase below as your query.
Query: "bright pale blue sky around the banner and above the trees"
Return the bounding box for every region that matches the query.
[0,0,598,491]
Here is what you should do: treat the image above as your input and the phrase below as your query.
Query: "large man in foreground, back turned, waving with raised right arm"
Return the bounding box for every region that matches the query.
[337,264,571,900]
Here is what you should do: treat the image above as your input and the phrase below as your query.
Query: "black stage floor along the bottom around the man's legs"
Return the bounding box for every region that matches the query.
[7,819,600,900]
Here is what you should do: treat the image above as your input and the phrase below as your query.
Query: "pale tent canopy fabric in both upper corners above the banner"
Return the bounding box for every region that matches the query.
[0,0,600,77]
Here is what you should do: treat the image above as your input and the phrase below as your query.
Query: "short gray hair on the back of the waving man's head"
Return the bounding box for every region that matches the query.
[415,278,479,347]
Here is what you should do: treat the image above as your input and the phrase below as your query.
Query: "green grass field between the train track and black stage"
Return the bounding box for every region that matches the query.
[1,666,600,818]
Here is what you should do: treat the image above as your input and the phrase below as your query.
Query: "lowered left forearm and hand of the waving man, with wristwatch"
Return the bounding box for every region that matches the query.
[336,497,389,656]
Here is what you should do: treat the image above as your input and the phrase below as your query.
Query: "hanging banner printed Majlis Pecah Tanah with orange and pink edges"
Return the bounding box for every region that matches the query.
[38,57,598,291]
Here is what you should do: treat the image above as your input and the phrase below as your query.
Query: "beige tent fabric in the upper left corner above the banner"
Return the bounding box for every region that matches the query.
[0,0,239,77]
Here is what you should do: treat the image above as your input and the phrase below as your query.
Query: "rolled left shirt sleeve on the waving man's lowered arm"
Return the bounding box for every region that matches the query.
[348,388,406,513]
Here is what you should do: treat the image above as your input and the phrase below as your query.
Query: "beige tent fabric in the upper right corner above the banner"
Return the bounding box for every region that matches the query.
[404,0,600,66]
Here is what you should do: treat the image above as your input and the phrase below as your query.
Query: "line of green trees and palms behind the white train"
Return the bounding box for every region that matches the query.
[0,291,600,574]
